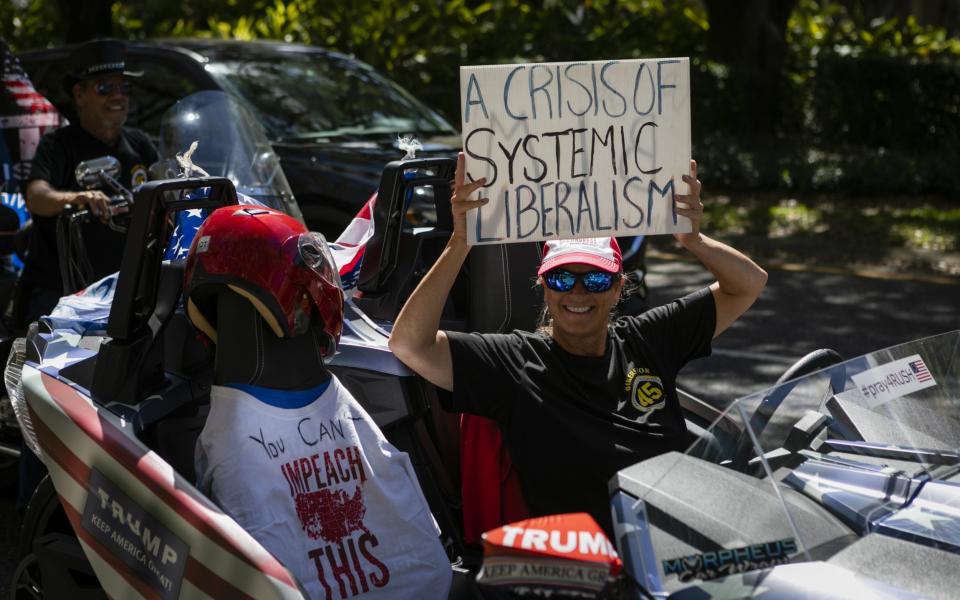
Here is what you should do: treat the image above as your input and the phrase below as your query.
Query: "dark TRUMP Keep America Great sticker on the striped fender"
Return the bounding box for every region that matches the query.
[81,469,190,598]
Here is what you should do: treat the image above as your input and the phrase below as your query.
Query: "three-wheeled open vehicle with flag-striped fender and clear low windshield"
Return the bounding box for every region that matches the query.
[5,90,960,598]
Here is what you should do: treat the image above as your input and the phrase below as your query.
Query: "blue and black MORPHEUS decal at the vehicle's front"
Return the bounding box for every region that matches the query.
[663,538,797,582]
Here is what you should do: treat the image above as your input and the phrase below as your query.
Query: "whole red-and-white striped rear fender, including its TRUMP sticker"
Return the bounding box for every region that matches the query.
[22,358,304,600]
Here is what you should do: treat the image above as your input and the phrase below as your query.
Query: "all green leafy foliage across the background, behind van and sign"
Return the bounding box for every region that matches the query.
[0,0,960,193]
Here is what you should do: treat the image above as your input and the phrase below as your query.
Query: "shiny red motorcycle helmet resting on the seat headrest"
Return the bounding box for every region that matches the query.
[184,206,343,358]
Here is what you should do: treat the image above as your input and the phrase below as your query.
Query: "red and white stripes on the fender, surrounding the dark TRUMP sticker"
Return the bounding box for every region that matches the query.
[23,363,303,600]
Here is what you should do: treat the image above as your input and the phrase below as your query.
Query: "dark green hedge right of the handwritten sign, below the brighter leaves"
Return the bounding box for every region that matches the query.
[691,55,960,194]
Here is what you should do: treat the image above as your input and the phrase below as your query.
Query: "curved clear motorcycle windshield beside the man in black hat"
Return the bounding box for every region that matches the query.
[160,90,303,221]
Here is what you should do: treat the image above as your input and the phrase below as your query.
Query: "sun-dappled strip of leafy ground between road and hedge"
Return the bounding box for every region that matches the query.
[688,190,960,283]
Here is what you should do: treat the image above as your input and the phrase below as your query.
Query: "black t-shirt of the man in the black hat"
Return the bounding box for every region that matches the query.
[22,124,157,290]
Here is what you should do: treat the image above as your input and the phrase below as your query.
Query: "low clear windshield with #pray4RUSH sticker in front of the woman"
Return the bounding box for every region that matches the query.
[614,331,960,593]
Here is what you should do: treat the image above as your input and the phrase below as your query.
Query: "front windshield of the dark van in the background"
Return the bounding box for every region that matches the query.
[207,52,455,140]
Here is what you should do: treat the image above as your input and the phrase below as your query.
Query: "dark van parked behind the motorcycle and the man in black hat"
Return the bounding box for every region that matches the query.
[20,39,460,239]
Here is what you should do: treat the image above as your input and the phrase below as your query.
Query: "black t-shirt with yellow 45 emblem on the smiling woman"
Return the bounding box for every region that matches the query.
[444,288,716,534]
